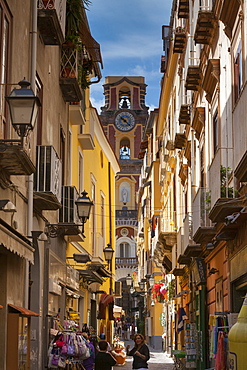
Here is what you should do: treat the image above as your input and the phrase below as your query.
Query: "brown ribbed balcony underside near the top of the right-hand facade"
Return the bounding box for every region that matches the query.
[194,10,217,45]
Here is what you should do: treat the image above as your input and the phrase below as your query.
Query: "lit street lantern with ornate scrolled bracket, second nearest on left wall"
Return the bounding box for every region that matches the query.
[46,190,93,238]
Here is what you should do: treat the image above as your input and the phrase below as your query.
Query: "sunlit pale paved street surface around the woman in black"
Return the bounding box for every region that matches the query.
[113,340,173,370]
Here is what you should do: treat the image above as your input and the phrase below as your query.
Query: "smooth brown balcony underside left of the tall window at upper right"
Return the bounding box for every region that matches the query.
[202,59,220,103]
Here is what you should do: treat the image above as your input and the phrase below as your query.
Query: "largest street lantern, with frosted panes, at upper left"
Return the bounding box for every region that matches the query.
[5,78,41,138]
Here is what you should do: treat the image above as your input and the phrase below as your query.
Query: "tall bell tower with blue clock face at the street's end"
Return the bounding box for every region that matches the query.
[100,76,148,313]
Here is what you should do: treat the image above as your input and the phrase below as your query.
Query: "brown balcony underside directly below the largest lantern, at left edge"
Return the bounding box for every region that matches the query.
[0,140,35,176]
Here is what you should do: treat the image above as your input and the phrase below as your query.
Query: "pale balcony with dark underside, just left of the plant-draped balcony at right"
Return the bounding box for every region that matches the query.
[192,188,216,244]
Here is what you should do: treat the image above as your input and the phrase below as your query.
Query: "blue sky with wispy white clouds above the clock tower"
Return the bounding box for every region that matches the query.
[87,0,172,113]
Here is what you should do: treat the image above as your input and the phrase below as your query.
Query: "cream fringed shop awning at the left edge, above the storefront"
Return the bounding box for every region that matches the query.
[0,218,34,264]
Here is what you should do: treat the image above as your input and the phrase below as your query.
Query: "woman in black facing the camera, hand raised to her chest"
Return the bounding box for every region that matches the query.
[126,334,150,370]
